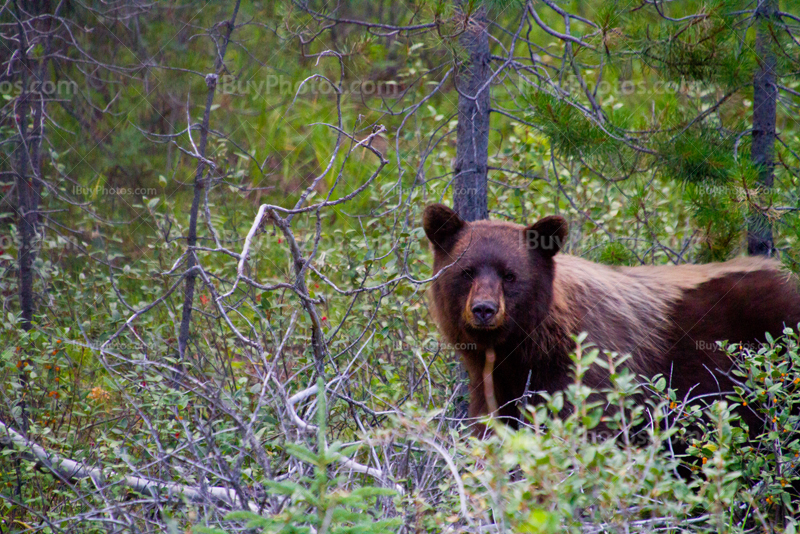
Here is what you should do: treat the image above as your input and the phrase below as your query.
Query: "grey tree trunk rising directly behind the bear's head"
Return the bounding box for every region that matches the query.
[453,1,491,221]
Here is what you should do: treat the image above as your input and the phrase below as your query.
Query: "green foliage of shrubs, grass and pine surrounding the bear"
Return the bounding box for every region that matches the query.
[0,0,800,532]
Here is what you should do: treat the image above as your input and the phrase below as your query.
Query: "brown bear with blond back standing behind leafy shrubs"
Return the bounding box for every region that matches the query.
[423,204,800,433]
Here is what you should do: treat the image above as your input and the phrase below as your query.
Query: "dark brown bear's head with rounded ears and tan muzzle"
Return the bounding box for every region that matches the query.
[423,204,567,348]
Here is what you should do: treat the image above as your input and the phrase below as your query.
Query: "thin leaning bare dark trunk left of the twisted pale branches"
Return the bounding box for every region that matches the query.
[178,0,240,363]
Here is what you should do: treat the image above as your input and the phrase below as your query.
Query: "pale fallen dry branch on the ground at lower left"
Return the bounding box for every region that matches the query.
[0,422,258,513]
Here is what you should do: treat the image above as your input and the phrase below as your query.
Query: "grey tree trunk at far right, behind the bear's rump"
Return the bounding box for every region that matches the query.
[747,0,778,256]
